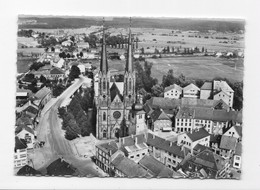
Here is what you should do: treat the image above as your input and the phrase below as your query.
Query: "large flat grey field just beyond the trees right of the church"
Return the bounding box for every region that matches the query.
[147,57,244,82]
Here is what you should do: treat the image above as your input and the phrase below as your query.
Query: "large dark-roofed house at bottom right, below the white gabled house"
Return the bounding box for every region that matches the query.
[180,149,230,179]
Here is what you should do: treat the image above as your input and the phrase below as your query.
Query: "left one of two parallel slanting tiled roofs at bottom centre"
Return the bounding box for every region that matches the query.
[112,154,147,177]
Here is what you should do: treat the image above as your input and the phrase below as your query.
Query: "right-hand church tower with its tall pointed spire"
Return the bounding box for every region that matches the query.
[123,18,136,109]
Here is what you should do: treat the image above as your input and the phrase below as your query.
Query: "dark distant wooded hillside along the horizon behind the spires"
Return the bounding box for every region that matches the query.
[19,17,245,32]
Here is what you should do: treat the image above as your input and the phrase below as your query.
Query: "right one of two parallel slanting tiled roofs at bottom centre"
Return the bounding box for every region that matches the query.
[139,155,173,177]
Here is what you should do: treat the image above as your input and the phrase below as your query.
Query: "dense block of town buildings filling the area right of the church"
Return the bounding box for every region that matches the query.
[95,81,242,178]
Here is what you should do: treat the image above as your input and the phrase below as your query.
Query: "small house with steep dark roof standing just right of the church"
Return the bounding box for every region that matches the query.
[151,109,172,132]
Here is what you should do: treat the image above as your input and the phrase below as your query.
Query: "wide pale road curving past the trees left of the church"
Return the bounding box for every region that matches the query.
[35,77,104,176]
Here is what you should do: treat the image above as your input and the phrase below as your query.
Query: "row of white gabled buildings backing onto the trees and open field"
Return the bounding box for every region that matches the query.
[164,80,234,108]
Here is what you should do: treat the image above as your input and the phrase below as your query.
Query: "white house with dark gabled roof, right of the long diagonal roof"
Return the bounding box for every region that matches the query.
[177,128,210,153]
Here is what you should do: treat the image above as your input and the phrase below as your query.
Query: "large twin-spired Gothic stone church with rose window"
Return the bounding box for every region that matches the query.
[94,23,146,139]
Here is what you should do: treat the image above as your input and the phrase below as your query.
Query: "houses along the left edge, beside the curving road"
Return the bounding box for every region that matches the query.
[14,87,52,168]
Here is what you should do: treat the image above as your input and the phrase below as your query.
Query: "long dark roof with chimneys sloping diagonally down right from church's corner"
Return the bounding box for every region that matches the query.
[147,133,184,158]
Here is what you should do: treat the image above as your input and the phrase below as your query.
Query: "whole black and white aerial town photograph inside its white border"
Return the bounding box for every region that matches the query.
[14,15,245,179]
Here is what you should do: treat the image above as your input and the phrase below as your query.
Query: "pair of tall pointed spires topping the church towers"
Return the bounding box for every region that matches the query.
[100,17,133,73]
